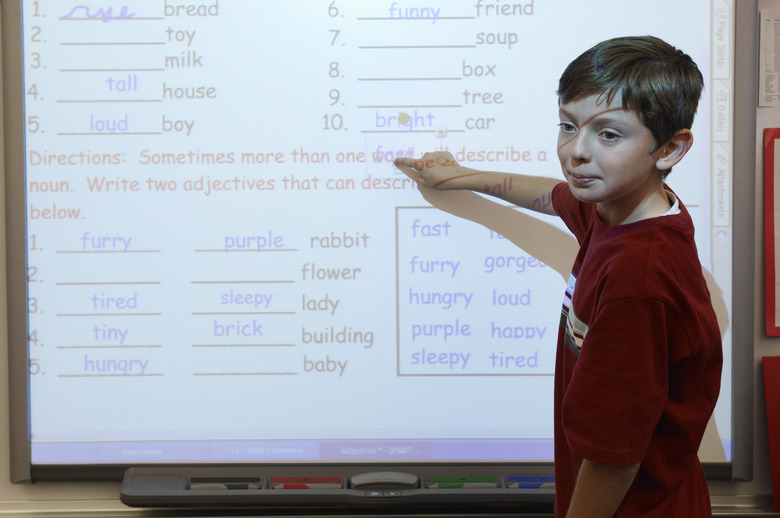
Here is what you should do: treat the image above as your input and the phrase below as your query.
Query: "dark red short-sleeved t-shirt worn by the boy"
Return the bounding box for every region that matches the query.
[553,183,722,518]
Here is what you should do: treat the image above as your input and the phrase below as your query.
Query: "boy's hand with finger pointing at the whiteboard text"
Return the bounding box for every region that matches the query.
[395,151,483,191]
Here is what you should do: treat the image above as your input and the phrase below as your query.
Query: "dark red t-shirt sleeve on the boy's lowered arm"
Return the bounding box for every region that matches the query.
[562,297,668,466]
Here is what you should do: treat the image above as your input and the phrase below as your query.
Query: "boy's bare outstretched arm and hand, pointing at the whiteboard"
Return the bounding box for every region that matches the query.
[395,151,562,216]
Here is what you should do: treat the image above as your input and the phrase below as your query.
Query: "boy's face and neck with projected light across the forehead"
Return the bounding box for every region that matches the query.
[558,95,669,224]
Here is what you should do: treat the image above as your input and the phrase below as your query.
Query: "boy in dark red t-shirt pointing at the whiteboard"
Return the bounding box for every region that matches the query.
[396,37,722,518]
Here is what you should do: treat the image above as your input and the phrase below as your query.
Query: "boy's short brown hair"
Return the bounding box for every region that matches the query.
[558,36,704,175]
